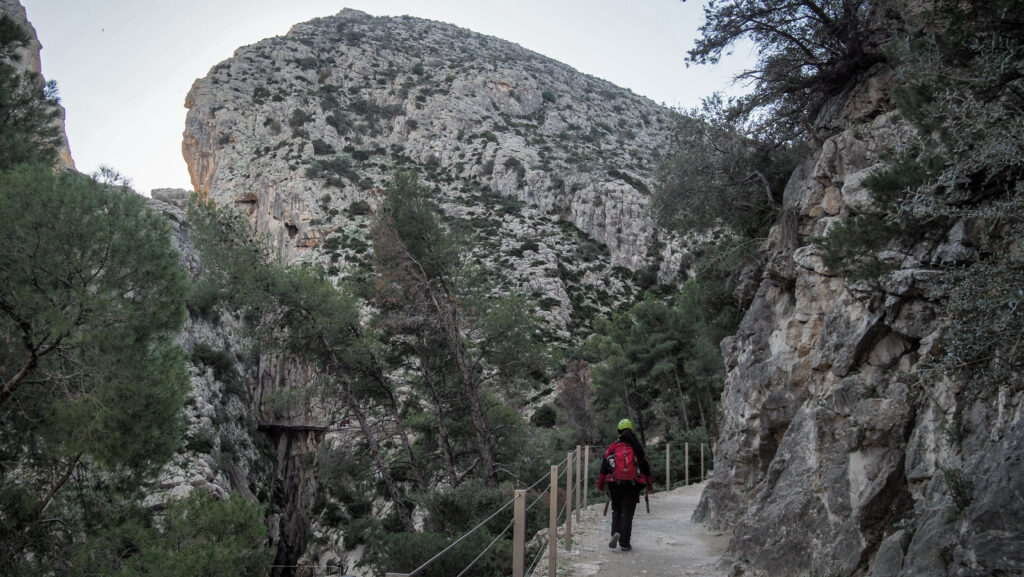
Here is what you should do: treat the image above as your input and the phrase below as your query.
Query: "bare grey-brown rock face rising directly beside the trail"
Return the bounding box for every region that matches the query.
[695,88,1024,577]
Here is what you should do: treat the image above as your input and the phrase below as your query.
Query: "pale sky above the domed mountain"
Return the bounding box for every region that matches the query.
[22,0,752,194]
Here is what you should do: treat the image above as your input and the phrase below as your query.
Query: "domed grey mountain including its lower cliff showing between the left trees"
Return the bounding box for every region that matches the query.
[153,10,688,569]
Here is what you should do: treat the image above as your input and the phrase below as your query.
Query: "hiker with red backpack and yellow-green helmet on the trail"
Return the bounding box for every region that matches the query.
[597,419,653,551]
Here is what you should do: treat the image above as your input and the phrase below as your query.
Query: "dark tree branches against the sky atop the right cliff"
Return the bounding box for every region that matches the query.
[687,0,899,141]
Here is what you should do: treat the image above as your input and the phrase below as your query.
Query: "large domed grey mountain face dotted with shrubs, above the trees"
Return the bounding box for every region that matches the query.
[182,10,684,319]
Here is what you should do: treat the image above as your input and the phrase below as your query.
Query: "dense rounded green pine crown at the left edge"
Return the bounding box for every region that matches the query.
[0,166,186,466]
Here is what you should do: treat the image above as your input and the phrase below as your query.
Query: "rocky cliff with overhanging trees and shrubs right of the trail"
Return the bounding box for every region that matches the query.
[655,0,1024,575]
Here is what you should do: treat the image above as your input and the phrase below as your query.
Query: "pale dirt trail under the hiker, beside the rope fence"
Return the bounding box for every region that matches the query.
[534,484,729,577]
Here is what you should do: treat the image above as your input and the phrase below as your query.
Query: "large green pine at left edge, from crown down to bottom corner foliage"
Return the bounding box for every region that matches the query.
[0,165,188,575]
